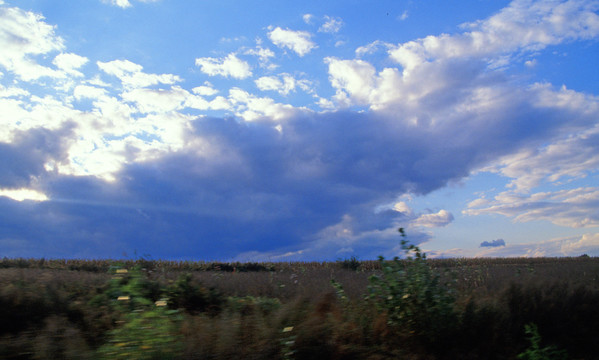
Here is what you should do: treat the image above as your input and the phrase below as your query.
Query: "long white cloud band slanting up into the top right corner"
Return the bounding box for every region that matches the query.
[389,0,599,75]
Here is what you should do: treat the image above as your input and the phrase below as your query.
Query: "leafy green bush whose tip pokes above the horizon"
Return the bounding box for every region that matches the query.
[366,228,455,342]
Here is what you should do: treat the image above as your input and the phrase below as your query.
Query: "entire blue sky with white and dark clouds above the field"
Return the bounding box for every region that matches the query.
[0,0,599,261]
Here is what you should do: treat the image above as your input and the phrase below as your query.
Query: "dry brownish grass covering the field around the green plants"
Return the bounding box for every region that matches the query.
[0,257,599,359]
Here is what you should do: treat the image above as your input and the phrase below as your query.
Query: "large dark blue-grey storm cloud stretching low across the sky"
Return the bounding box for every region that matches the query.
[0,81,592,259]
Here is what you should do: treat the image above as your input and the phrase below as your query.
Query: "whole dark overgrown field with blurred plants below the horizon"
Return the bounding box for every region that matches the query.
[0,247,599,359]
